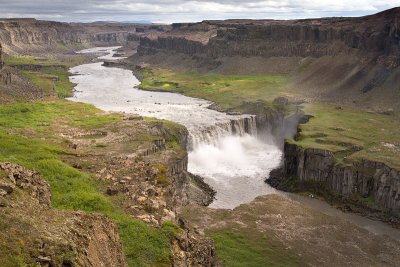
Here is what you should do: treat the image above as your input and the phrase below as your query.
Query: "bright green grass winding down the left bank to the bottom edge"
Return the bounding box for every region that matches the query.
[0,56,183,266]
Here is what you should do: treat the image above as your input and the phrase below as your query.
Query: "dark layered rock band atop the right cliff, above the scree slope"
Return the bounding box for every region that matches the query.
[139,8,400,62]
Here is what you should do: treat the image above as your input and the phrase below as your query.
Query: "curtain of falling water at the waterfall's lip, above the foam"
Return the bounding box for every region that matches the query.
[188,116,257,151]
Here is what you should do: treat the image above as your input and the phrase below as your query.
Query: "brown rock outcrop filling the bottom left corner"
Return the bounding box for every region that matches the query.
[0,162,127,267]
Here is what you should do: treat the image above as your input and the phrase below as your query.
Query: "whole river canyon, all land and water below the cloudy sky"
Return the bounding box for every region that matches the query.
[0,8,400,266]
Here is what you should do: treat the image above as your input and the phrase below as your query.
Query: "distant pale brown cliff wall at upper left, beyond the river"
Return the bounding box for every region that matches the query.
[0,19,164,54]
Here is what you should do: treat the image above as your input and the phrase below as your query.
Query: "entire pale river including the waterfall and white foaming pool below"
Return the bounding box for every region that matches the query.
[70,47,282,208]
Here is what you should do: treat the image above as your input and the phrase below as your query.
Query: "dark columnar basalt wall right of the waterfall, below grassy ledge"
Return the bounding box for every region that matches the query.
[284,143,400,215]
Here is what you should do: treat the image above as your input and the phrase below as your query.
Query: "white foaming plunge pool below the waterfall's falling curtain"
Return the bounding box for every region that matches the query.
[188,134,282,208]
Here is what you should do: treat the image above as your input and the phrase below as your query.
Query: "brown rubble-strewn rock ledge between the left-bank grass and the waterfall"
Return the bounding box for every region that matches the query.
[63,115,216,266]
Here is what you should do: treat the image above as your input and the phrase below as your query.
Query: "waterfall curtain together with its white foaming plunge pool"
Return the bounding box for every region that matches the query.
[188,116,281,208]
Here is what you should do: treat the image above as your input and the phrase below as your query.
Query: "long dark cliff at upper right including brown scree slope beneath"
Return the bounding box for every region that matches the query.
[134,8,400,110]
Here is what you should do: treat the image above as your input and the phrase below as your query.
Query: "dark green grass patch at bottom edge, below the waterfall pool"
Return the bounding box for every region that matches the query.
[208,230,304,267]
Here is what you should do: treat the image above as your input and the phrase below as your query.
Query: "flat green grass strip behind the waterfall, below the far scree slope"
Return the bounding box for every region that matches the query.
[139,68,289,109]
